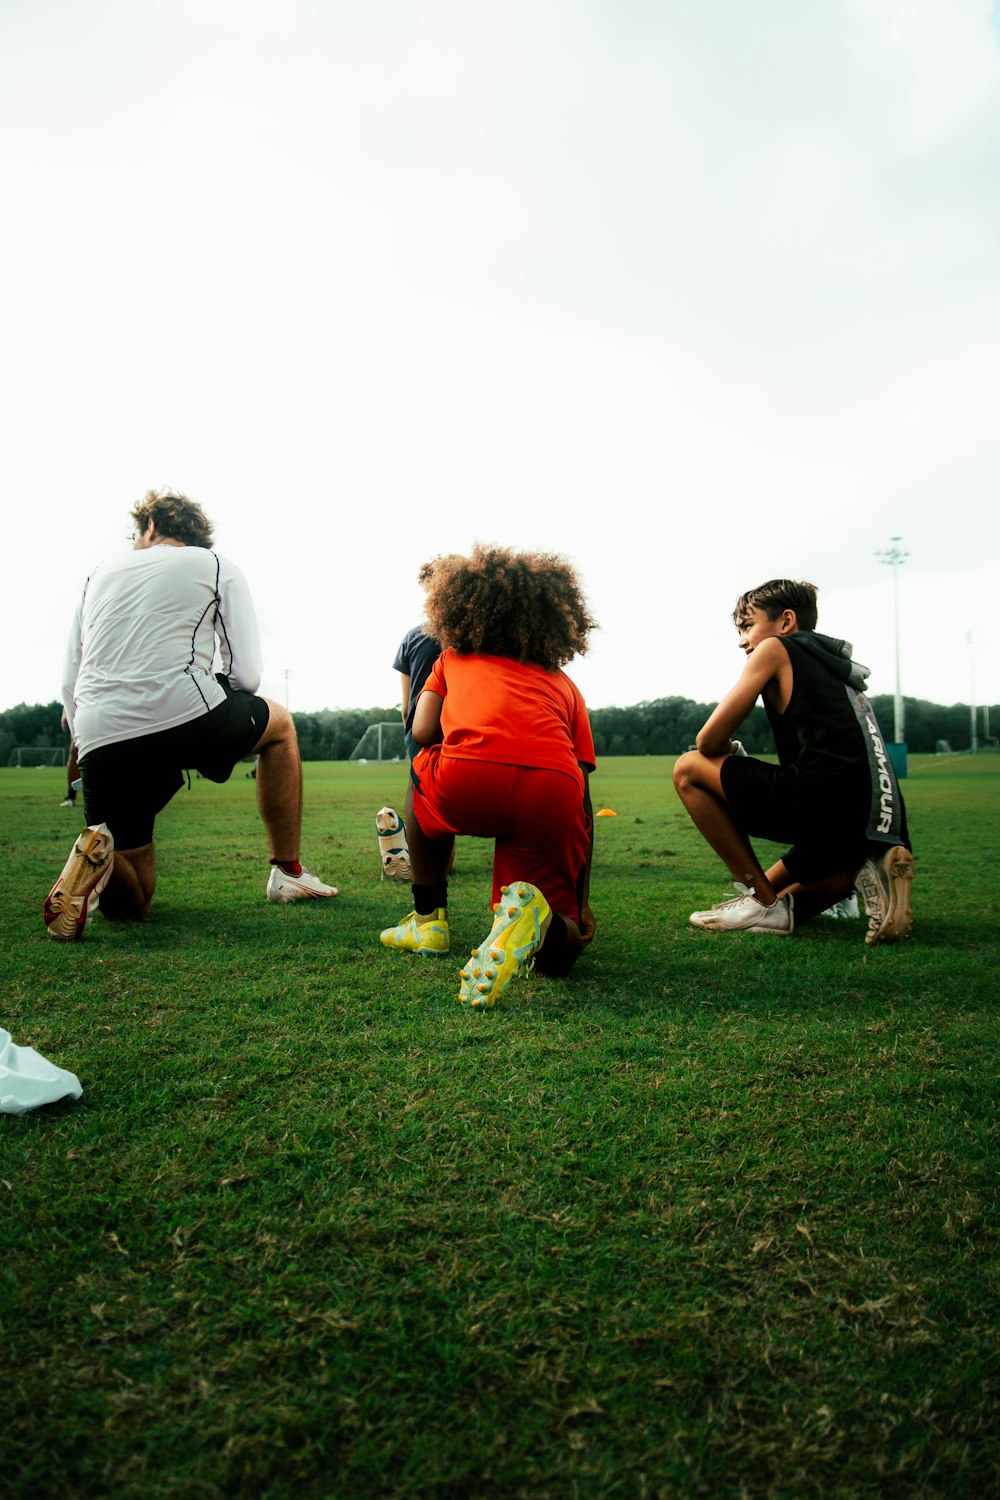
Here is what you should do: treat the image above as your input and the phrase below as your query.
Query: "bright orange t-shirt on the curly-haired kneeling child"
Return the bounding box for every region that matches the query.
[423,647,594,776]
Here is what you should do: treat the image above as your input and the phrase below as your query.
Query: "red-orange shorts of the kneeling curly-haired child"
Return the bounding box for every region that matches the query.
[411,746,591,923]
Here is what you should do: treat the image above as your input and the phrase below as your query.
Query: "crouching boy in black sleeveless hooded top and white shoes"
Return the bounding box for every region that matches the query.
[673,579,913,944]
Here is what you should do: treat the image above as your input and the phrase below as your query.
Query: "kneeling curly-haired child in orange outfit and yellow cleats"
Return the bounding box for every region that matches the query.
[381,545,595,1007]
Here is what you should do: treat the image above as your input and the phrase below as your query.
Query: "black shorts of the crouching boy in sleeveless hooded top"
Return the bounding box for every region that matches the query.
[720,755,871,885]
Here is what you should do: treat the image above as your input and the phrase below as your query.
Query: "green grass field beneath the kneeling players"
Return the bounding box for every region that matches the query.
[0,756,1000,1500]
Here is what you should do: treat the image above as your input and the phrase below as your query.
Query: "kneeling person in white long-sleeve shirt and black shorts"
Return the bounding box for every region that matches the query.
[43,491,337,942]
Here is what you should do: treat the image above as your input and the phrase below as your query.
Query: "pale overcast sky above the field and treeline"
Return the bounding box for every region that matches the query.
[0,0,1000,732]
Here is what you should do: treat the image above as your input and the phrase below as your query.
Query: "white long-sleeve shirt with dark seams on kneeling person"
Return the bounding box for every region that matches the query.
[63,545,261,756]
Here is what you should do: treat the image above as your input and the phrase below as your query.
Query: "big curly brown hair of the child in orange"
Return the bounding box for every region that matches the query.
[417,542,597,672]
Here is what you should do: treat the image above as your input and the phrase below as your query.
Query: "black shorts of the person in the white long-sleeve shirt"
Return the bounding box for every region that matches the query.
[79,680,270,849]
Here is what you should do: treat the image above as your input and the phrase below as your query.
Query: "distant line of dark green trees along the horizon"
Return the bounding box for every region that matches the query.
[0,693,1000,767]
